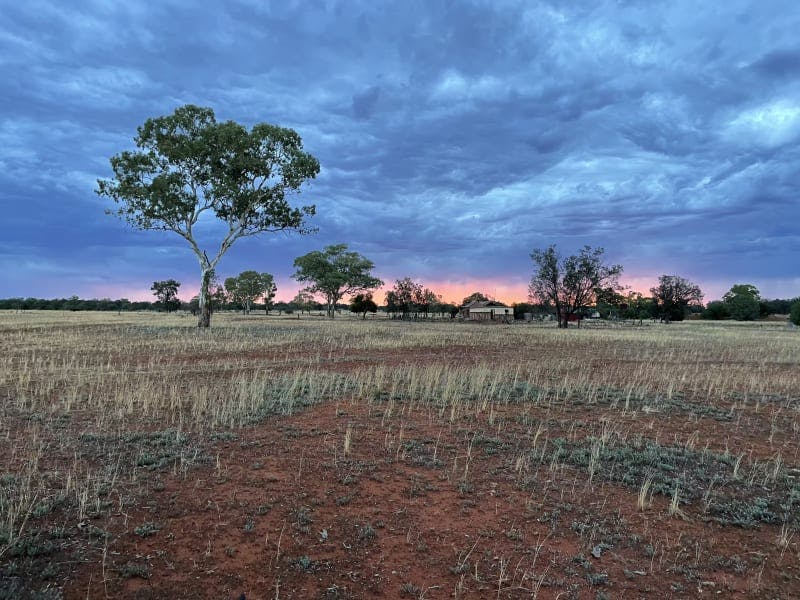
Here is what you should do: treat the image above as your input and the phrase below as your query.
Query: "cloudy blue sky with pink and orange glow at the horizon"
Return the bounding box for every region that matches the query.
[0,0,800,302]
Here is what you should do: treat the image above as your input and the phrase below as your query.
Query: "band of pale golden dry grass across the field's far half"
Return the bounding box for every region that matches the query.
[0,311,800,428]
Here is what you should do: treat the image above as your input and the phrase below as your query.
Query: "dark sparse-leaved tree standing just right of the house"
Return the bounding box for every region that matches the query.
[528,246,622,328]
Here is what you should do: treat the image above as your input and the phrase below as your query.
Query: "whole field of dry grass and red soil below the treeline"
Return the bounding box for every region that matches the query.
[0,312,800,600]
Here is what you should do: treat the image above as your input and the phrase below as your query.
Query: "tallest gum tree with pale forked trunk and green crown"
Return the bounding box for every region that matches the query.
[101,105,319,327]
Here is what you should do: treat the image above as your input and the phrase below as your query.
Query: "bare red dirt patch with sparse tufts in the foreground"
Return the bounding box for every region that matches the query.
[56,402,800,600]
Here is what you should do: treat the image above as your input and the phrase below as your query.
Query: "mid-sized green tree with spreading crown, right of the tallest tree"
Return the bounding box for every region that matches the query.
[292,244,383,319]
